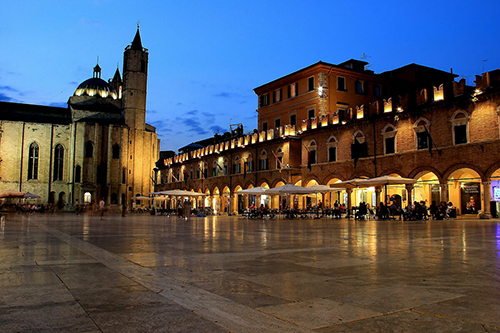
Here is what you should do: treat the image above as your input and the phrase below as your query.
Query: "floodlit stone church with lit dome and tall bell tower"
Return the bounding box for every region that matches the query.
[0,28,160,209]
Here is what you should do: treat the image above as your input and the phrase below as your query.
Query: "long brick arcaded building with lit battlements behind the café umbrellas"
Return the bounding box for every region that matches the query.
[156,60,500,214]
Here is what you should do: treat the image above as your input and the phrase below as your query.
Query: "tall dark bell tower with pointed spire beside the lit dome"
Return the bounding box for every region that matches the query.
[122,25,149,130]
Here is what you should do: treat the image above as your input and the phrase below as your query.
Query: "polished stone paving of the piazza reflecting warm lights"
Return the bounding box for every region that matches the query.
[0,214,500,333]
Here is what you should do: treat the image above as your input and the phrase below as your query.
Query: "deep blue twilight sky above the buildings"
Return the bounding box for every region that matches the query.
[0,0,500,150]
